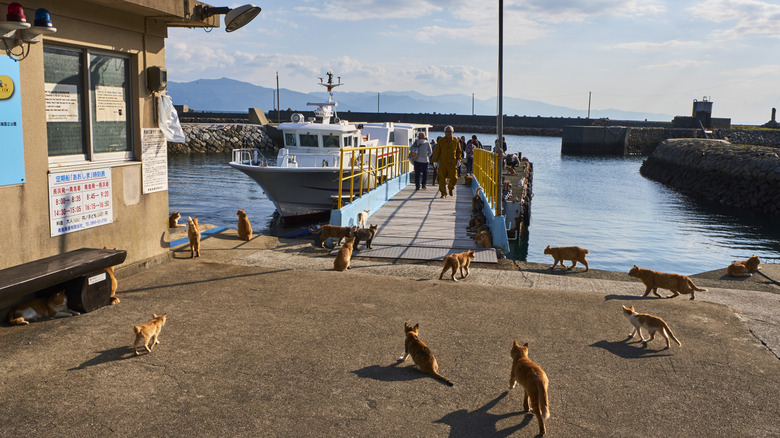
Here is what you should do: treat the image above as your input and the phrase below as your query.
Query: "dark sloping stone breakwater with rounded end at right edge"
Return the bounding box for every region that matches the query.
[640,139,780,216]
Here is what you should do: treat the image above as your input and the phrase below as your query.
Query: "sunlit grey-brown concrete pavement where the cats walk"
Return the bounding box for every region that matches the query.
[0,230,780,437]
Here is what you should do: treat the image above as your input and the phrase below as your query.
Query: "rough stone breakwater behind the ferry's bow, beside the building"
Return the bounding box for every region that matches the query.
[168,124,278,156]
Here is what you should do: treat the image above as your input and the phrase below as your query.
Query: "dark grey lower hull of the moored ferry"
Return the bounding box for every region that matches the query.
[230,162,368,221]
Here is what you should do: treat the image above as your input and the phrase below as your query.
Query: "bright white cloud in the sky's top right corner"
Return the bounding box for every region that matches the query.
[688,0,780,40]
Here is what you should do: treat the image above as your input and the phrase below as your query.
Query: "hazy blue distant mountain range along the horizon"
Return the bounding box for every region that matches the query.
[168,78,674,121]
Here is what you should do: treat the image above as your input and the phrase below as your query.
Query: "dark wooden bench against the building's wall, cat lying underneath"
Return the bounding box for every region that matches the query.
[0,248,127,322]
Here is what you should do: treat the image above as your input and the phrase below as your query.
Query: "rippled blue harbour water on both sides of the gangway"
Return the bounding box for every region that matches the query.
[168,132,780,275]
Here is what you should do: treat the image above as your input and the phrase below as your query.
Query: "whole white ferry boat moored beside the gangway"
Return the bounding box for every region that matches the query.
[225,72,431,222]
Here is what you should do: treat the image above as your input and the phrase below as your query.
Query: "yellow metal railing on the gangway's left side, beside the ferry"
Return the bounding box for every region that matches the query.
[337,145,409,208]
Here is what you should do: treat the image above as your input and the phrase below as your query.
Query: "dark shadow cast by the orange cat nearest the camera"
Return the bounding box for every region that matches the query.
[434,389,534,438]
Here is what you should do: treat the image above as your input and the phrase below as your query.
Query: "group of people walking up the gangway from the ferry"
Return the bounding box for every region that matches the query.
[409,126,506,198]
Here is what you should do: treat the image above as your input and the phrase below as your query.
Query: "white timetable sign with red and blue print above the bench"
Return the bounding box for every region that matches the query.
[49,168,114,237]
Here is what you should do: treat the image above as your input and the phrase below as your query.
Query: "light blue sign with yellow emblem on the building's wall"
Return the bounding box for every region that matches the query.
[0,56,24,186]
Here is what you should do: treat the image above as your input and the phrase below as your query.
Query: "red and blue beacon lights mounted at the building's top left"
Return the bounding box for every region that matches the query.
[0,2,57,61]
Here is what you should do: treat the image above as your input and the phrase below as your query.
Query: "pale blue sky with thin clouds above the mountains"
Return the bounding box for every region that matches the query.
[166,0,780,124]
